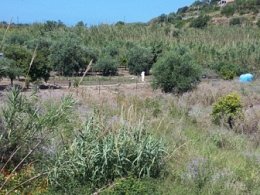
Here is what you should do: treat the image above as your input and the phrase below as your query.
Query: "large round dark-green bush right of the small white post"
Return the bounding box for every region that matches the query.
[152,48,201,93]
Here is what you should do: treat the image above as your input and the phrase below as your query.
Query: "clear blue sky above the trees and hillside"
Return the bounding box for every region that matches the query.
[0,0,195,25]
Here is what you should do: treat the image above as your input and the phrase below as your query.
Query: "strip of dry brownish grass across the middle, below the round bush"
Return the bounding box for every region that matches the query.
[7,77,260,136]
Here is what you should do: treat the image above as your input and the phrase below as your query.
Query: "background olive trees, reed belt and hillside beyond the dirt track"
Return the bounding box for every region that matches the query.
[0,0,260,85]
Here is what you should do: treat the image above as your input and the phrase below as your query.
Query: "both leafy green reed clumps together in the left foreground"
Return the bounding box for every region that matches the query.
[0,88,167,193]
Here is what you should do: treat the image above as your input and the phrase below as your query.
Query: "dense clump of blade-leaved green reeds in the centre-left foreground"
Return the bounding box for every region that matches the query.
[49,118,166,191]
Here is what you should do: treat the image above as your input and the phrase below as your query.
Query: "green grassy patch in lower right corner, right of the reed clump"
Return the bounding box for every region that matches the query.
[144,80,260,194]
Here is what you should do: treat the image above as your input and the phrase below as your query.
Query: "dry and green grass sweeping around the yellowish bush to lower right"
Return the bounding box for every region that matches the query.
[62,81,260,194]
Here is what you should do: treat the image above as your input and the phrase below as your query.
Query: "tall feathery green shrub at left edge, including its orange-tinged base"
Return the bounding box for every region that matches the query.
[0,87,74,192]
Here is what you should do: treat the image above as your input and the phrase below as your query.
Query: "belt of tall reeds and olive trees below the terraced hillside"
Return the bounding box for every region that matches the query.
[0,15,260,81]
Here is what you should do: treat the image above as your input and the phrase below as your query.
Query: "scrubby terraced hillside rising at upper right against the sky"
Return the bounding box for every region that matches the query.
[149,0,260,28]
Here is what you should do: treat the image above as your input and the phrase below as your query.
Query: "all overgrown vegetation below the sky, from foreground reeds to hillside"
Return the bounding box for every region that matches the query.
[0,0,260,194]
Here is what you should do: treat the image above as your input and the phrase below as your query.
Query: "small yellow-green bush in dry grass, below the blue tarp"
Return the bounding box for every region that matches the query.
[212,93,242,129]
